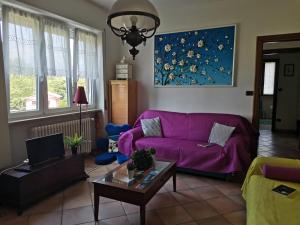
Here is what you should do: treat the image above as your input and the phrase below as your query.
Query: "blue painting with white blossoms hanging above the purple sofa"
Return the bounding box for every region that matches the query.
[154,25,236,87]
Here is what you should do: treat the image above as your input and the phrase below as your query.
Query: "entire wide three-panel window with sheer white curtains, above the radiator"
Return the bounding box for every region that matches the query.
[1,6,100,118]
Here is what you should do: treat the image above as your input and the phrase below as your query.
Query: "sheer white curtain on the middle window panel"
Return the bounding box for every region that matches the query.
[43,19,71,77]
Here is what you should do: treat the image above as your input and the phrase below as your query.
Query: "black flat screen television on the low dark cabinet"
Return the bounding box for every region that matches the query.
[26,134,65,166]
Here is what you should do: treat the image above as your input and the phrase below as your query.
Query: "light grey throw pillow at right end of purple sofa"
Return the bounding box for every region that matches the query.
[208,123,235,147]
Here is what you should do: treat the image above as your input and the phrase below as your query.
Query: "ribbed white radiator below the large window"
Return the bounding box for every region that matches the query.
[31,118,93,153]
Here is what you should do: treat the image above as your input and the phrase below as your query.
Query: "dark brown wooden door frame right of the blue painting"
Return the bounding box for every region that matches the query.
[252,33,300,130]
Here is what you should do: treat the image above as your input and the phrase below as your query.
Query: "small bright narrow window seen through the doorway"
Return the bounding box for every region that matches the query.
[263,62,276,95]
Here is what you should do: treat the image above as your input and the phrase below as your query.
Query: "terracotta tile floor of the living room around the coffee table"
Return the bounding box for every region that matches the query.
[0,158,245,225]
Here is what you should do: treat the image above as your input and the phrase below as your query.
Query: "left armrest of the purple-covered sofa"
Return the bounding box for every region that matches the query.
[118,127,144,156]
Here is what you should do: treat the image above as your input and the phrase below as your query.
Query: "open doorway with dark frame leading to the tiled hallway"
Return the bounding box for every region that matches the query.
[252,33,300,158]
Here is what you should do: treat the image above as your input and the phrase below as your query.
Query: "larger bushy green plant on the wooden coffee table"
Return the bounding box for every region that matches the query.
[131,148,156,170]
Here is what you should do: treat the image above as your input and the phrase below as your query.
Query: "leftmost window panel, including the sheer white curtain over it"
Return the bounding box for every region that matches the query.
[3,9,39,113]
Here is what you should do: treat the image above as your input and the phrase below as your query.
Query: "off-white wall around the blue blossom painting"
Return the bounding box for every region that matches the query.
[122,0,300,118]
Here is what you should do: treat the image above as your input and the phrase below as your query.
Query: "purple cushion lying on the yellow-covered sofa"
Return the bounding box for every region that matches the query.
[262,164,300,183]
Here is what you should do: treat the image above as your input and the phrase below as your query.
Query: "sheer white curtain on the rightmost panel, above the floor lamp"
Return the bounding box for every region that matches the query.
[73,29,99,80]
